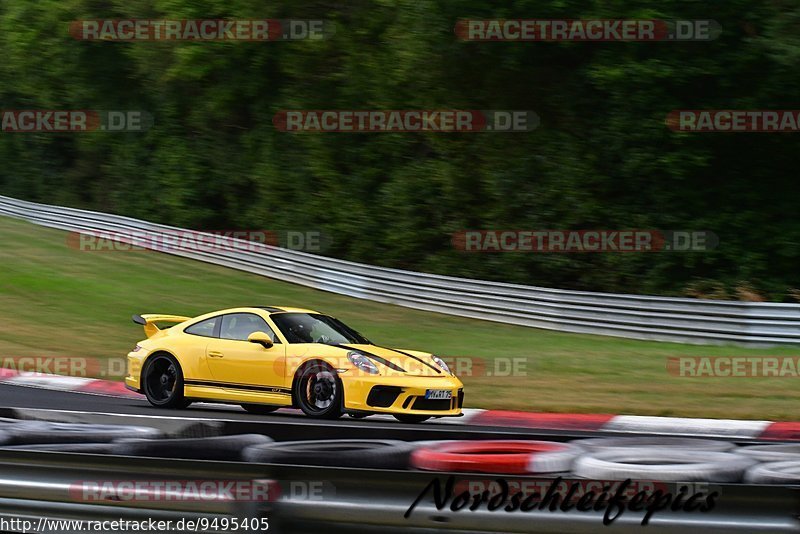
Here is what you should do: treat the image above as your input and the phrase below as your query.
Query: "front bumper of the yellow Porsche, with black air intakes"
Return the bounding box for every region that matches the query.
[339,373,464,417]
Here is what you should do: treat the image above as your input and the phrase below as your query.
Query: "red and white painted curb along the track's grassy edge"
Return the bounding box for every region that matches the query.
[0,368,800,441]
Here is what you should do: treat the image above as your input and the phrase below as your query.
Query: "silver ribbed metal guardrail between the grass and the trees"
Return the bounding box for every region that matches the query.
[0,196,800,346]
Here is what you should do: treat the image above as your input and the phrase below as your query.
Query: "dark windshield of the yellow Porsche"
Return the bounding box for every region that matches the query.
[270,313,370,345]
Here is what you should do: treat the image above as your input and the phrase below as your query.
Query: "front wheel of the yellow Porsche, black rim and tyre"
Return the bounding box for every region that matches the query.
[294,362,344,419]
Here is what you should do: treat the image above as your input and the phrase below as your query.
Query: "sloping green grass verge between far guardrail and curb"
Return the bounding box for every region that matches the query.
[0,217,800,420]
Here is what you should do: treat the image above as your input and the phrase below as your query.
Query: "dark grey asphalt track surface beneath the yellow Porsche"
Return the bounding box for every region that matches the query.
[0,384,769,444]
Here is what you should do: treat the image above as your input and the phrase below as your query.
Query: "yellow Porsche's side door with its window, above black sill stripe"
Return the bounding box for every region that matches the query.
[206,313,286,389]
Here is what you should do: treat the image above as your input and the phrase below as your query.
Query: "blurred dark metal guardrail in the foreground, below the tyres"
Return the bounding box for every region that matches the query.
[0,450,800,534]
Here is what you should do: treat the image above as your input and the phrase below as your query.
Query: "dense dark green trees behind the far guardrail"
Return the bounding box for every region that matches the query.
[0,0,800,300]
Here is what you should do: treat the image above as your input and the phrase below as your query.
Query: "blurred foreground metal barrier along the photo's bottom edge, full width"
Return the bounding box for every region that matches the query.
[0,449,800,534]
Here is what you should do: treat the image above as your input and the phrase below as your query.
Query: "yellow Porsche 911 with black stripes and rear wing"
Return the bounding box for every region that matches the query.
[125,306,464,423]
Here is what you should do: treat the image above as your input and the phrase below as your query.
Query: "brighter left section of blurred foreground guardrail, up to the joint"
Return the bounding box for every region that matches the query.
[0,449,280,533]
